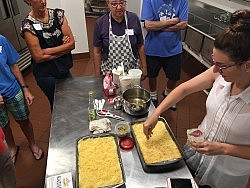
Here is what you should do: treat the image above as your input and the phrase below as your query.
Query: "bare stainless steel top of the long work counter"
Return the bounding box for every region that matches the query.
[46,77,192,188]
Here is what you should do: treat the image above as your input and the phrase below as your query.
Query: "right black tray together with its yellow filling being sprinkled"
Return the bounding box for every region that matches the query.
[131,117,182,172]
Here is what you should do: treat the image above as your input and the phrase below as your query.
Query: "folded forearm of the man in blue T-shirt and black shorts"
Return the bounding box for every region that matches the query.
[144,18,180,31]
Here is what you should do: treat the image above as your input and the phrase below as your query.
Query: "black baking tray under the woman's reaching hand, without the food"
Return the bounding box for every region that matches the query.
[131,117,183,173]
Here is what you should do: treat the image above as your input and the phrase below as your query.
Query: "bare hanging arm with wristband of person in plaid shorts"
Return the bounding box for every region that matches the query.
[10,64,34,105]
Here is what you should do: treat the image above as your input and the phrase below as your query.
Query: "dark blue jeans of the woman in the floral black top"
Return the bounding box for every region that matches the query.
[35,72,72,112]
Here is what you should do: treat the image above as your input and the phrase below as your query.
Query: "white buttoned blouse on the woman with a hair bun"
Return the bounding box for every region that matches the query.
[192,76,250,188]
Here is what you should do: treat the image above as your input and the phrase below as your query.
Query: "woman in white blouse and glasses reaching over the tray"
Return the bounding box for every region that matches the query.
[144,10,250,188]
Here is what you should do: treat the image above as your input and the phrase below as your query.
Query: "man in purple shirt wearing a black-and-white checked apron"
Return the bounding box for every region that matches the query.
[93,0,147,80]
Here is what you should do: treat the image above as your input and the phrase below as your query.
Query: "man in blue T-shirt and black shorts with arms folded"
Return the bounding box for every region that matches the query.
[141,0,188,109]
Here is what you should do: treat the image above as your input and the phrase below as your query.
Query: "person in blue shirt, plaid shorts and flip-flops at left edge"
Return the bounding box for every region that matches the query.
[0,35,43,163]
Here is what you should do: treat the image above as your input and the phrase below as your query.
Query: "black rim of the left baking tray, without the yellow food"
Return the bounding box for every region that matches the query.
[76,133,126,188]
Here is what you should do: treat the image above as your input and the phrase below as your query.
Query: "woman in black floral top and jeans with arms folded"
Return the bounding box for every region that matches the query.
[21,0,75,110]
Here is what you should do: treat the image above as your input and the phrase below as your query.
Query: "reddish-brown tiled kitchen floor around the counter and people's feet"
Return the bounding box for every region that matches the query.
[11,18,250,188]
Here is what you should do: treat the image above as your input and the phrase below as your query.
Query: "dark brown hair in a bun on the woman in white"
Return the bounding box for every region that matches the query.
[214,9,250,64]
